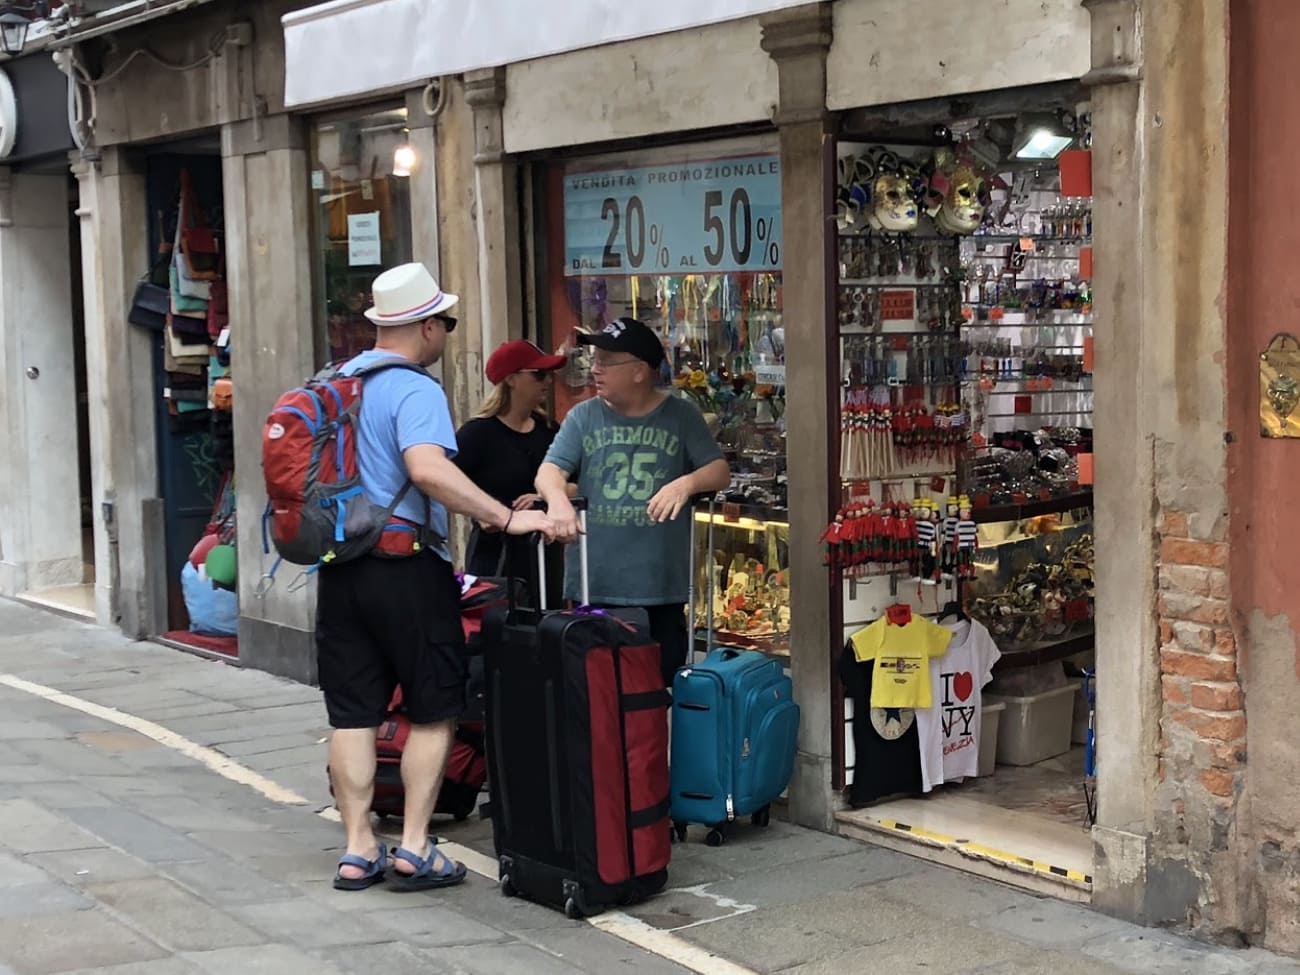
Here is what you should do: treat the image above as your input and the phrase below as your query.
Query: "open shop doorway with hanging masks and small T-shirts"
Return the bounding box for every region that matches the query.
[829,86,1096,900]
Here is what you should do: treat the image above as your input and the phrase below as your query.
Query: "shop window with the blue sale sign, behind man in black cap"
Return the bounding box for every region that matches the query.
[547,142,790,655]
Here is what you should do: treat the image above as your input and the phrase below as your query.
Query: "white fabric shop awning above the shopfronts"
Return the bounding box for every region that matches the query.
[283,0,807,108]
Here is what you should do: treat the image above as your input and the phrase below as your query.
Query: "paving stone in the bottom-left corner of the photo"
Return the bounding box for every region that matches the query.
[0,910,166,975]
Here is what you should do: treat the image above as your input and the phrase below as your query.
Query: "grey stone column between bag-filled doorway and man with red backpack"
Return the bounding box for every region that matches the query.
[221,116,324,683]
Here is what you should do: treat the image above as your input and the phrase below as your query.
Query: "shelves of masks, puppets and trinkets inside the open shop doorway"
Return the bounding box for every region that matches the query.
[823,137,1092,668]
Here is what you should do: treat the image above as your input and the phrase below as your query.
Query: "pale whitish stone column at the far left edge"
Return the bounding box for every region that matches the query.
[0,169,85,595]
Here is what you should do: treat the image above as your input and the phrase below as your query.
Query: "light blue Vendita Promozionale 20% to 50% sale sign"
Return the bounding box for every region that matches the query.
[564,155,781,276]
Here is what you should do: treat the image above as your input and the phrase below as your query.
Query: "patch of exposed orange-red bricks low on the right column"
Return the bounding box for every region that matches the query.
[1157,511,1245,803]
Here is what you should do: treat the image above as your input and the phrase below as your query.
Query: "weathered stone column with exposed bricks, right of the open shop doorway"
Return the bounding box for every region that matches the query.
[1083,0,1249,937]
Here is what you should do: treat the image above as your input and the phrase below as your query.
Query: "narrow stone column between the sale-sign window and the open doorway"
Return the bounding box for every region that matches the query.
[762,3,839,829]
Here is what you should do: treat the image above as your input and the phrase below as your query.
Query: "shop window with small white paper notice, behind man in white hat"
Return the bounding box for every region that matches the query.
[311,108,412,361]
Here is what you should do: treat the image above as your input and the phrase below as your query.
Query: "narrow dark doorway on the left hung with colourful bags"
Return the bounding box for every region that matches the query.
[142,143,239,658]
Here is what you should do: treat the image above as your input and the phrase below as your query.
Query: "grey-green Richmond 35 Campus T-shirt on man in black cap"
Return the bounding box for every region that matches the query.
[546,397,723,606]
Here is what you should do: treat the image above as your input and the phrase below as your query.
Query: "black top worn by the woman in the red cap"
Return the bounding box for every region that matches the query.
[455,416,564,608]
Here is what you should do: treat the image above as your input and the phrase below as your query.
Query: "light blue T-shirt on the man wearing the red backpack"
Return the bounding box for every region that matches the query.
[341,348,456,562]
